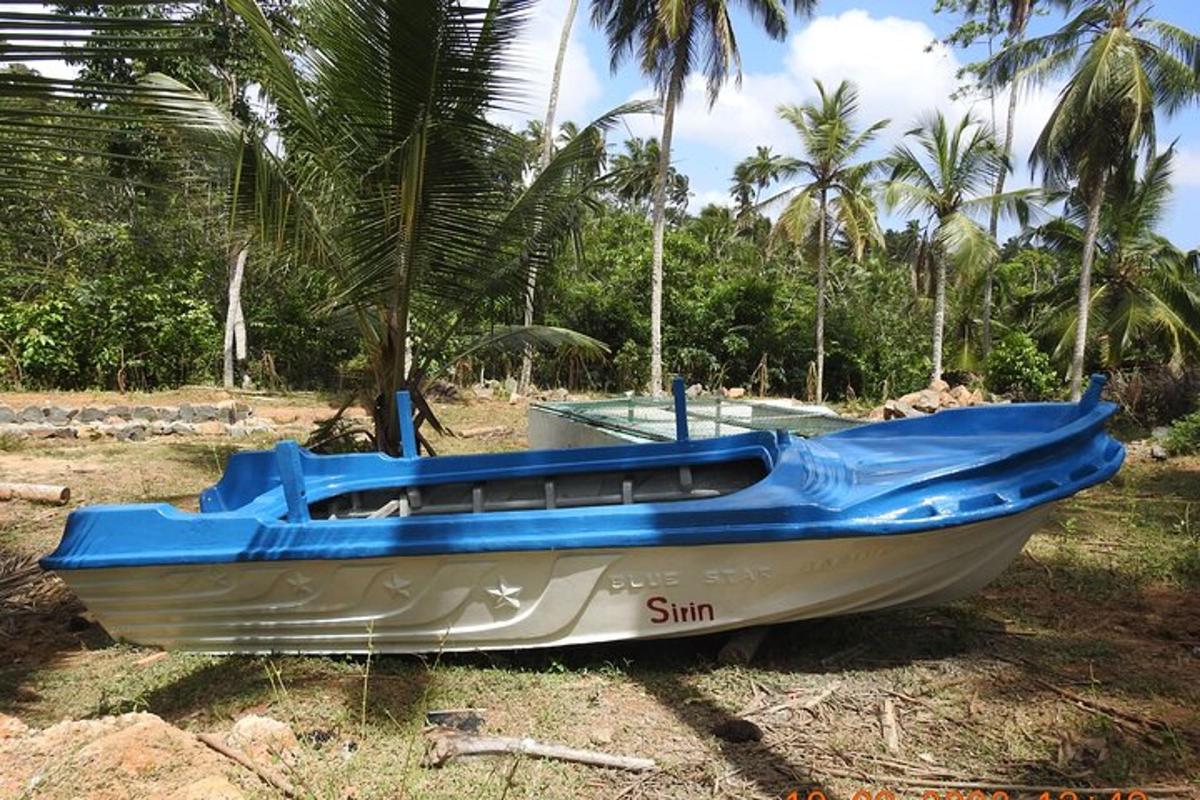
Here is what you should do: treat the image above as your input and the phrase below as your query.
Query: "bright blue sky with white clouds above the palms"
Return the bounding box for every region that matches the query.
[512,0,1200,248]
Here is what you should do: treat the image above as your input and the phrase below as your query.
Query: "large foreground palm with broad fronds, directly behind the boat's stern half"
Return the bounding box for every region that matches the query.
[154,0,629,452]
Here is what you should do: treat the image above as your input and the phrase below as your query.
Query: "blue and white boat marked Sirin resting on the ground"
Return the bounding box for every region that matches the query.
[42,378,1124,652]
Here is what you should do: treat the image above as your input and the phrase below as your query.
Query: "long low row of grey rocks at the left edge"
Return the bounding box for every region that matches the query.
[0,401,274,441]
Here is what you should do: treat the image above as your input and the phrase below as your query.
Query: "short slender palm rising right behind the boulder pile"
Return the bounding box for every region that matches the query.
[884,113,1032,381]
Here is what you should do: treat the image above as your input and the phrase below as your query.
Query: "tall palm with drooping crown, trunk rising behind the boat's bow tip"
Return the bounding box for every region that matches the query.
[984,0,1200,398]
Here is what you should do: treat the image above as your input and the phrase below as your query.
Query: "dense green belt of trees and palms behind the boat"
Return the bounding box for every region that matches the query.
[0,0,1200,434]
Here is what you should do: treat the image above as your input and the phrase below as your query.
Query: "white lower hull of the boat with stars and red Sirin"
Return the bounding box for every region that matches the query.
[62,505,1050,652]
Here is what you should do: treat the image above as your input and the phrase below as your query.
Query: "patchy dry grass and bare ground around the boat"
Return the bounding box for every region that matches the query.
[0,391,1200,800]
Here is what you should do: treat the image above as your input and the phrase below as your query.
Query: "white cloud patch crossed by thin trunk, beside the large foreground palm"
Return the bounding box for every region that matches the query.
[502,0,601,125]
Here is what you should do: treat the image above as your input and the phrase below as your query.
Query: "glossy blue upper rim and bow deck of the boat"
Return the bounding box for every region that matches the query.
[43,384,1124,570]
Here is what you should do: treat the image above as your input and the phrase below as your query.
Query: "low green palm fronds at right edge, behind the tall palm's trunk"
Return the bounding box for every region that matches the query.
[1033,148,1200,368]
